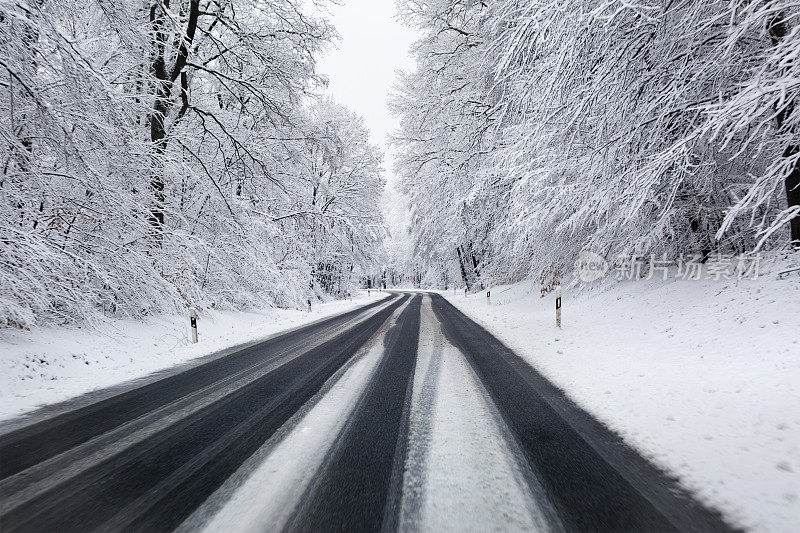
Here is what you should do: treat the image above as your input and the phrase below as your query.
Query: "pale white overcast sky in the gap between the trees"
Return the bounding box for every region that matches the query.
[318,0,415,182]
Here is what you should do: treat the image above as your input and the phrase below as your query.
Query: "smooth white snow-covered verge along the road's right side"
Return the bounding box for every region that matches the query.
[443,256,800,532]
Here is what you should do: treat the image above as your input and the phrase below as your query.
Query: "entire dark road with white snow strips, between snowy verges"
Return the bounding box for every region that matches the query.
[0,293,731,533]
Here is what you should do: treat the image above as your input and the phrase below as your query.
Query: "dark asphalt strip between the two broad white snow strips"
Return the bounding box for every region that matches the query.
[286,295,422,531]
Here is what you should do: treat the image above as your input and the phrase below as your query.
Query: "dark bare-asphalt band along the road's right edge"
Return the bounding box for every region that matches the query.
[432,294,731,531]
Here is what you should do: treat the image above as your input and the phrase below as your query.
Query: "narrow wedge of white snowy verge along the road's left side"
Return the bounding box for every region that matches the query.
[0,291,386,420]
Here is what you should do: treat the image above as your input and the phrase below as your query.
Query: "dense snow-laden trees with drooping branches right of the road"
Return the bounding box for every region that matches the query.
[393,0,800,286]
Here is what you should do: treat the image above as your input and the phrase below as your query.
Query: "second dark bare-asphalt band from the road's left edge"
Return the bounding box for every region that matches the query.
[2,297,407,531]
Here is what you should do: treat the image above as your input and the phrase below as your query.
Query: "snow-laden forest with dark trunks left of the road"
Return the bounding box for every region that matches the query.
[0,0,385,327]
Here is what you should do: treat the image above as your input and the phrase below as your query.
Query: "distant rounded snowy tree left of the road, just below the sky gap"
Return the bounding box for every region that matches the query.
[286,100,386,293]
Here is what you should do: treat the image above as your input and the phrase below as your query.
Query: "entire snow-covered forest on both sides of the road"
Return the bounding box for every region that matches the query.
[0,0,800,327]
